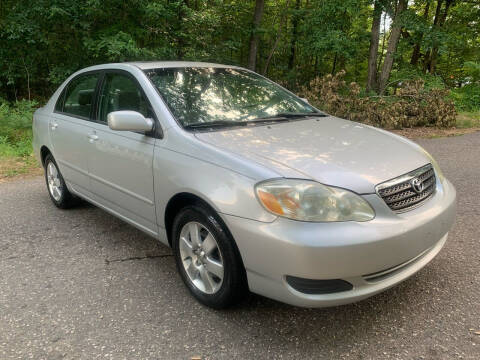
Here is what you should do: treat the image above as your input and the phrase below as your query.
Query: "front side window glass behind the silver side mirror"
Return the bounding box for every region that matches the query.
[98,73,152,122]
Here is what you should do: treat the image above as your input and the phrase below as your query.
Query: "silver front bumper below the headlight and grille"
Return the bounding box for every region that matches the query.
[223,179,456,307]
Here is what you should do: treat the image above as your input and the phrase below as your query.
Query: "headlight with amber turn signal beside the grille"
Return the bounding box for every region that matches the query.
[255,179,375,222]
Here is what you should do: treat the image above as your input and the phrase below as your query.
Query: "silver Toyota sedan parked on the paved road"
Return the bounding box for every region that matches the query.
[33,62,456,308]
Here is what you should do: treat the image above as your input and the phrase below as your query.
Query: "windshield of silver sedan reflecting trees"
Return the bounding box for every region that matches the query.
[145,67,317,126]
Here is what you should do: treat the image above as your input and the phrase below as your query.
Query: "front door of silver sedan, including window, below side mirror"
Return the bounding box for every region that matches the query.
[89,71,158,235]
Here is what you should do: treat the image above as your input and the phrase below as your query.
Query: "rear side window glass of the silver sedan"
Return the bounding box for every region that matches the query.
[63,74,98,119]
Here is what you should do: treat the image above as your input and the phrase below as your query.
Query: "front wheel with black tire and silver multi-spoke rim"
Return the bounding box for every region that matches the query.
[172,205,248,309]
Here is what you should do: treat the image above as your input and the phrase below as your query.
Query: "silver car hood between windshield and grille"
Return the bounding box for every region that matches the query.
[196,116,430,194]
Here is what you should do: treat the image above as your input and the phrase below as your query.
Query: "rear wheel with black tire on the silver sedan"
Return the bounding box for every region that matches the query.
[44,154,77,209]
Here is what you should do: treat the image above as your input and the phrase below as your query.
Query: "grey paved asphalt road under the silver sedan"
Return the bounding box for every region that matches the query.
[0,132,480,359]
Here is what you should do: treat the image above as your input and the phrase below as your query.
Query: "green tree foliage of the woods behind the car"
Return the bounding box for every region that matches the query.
[0,0,480,124]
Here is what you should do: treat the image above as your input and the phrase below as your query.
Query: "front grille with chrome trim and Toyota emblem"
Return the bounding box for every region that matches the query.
[375,164,436,213]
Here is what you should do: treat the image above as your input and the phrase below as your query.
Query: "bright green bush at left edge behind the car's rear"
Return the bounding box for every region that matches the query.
[0,100,38,157]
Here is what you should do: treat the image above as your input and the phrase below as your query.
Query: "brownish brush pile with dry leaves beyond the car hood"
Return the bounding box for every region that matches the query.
[301,71,456,129]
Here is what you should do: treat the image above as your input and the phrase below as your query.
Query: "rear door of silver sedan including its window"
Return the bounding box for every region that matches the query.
[49,72,100,194]
